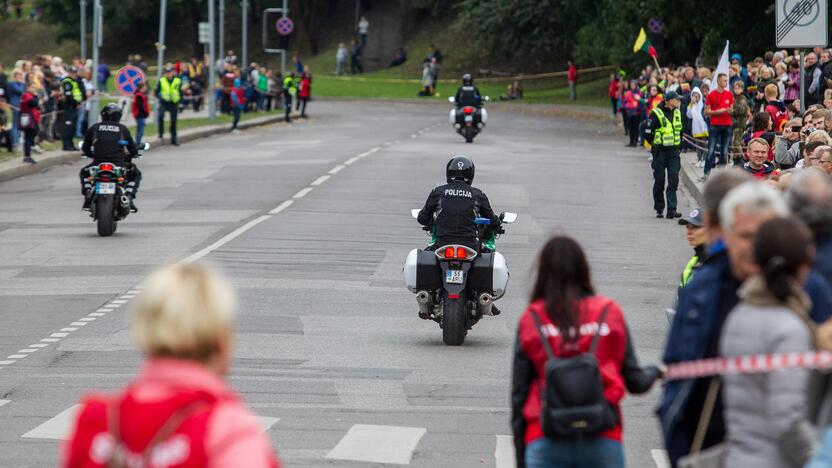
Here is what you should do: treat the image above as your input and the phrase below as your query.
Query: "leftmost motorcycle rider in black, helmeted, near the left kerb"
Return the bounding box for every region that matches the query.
[78,103,142,213]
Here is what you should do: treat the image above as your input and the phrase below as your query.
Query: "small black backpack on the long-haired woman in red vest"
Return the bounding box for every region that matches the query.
[532,305,617,439]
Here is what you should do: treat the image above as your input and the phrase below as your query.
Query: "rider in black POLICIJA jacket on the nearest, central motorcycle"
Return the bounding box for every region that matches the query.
[417,156,501,250]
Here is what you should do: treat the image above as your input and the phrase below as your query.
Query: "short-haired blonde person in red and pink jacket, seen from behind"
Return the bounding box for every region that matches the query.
[62,264,280,468]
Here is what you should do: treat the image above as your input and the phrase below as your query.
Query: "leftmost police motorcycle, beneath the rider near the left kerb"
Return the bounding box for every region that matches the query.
[78,141,150,237]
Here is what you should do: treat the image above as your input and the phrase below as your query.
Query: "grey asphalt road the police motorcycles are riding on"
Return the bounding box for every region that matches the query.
[0,102,689,468]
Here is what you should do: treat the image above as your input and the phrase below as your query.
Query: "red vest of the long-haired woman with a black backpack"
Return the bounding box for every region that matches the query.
[513,296,627,444]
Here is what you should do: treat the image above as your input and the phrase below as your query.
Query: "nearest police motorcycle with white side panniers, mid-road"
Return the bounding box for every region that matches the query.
[402,209,517,346]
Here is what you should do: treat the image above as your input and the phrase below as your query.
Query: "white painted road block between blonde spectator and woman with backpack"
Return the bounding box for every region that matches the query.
[326,424,427,465]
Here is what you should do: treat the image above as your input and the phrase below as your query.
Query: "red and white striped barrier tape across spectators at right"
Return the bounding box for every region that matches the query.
[664,351,832,380]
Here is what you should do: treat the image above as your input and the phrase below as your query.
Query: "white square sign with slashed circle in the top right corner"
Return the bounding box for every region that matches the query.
[775,0,829,49]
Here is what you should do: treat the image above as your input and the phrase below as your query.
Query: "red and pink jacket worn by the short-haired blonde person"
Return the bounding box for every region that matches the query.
[62,359,280,468]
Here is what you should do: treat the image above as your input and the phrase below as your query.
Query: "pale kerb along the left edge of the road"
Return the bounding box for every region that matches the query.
[0,114,284,182]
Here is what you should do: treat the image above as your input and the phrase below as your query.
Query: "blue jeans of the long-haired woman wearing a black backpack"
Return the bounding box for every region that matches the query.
[526,437,624,468]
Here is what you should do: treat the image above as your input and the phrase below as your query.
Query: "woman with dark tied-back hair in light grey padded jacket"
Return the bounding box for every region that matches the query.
[720,218,826,468]
